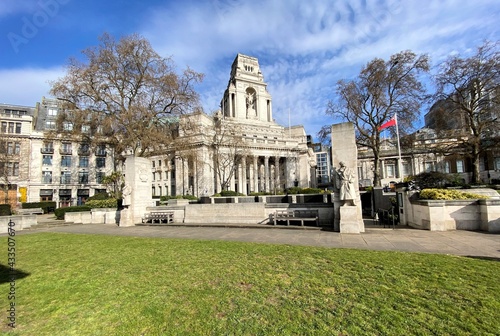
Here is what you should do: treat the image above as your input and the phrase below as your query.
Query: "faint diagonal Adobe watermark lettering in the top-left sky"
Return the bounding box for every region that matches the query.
[7,0,71,54]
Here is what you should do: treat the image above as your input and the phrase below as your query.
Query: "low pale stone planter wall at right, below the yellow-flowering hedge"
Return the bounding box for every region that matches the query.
[400,194,500,232]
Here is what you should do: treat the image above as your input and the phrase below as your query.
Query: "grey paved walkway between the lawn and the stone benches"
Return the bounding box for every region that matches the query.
[14,214,500,261]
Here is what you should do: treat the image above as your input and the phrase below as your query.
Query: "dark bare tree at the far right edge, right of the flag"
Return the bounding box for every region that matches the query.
[435,41,500,183]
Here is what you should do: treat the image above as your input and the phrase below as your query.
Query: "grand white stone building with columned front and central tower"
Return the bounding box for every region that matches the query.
[147,54,316,196]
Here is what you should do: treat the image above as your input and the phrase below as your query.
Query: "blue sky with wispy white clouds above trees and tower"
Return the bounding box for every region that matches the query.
[0,0,500,136]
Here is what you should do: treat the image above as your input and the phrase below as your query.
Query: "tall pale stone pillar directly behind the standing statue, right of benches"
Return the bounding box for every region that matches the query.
[331,123,365,233]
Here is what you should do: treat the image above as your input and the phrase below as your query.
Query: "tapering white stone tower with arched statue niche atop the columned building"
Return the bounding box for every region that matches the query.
[221,54,274,122]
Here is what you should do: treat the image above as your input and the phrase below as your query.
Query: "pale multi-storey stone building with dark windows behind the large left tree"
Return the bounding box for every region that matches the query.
[27,97,114,207]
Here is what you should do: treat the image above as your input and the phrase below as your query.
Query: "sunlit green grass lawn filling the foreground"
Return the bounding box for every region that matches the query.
[0,233,500,336]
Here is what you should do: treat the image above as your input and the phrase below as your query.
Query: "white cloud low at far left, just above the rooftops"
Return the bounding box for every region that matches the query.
[0,68,64,106]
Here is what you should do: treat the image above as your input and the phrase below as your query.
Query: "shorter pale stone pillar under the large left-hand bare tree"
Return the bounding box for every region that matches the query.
[120,156,153,226]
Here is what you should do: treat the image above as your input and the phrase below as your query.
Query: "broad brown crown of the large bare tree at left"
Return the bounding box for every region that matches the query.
[51,34,203,161]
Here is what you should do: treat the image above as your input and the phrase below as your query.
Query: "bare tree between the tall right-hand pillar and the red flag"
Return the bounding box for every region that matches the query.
[319,51,429,186]
